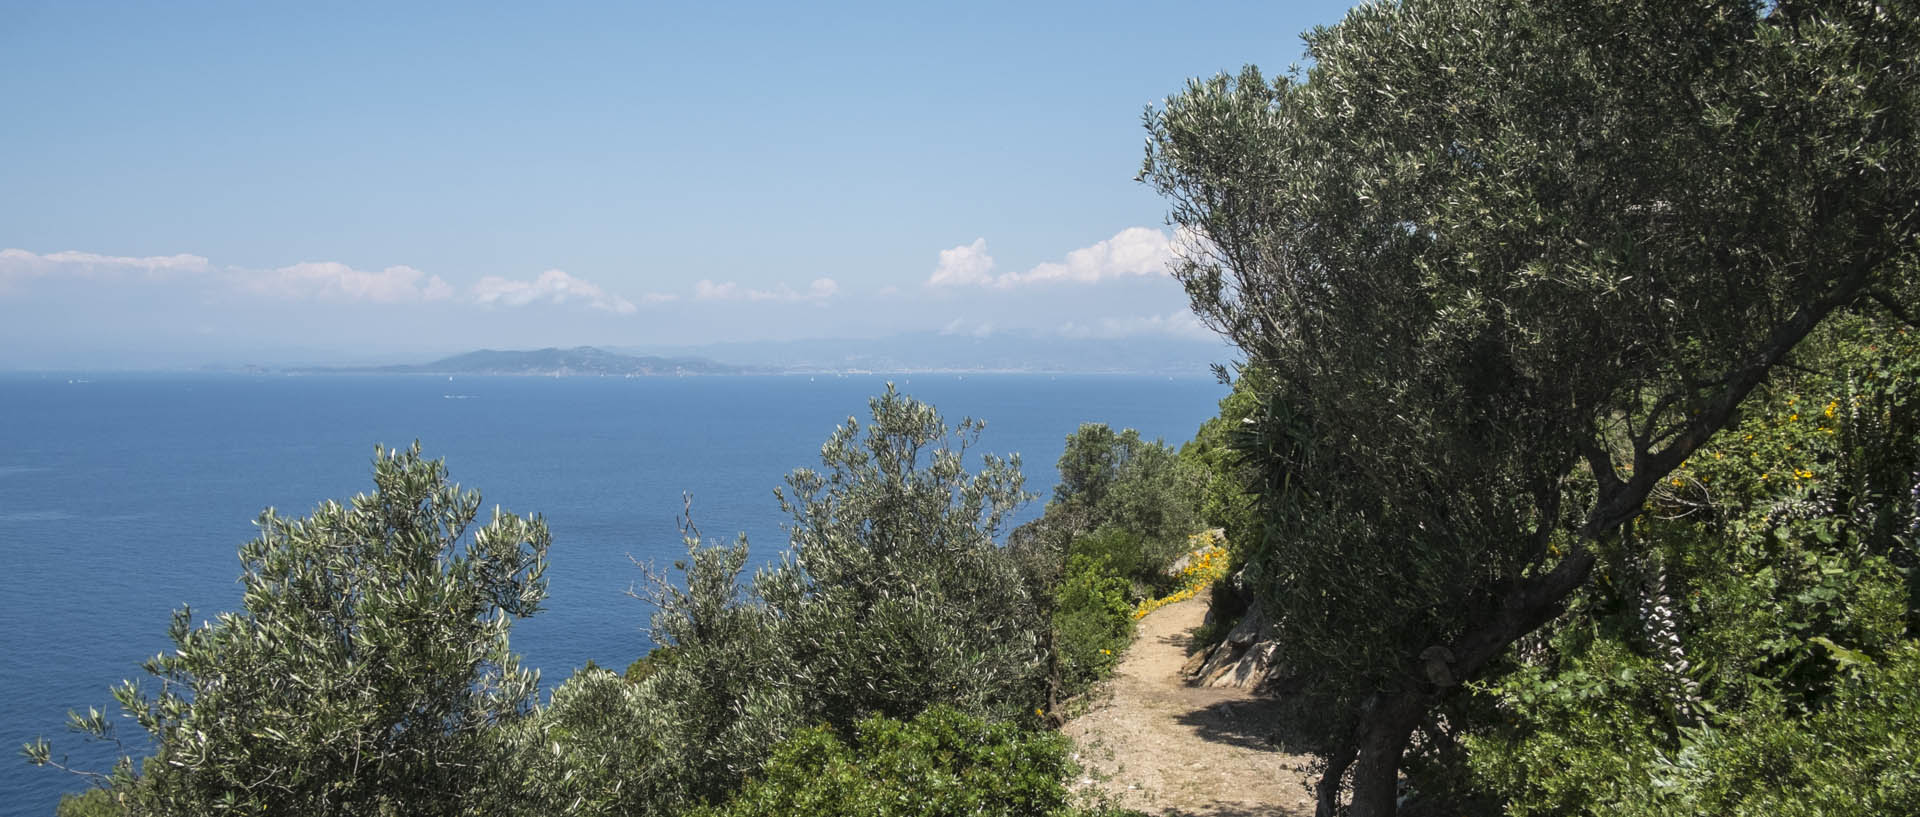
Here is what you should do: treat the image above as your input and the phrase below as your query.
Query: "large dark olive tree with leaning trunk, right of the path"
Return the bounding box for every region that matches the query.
[1142,0,1920,815]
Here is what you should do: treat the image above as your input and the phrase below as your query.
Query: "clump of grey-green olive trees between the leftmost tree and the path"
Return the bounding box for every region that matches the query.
[520,385,1048,815]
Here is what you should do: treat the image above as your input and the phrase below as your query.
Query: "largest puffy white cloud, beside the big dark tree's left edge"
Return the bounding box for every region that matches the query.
[927,226,1173,290]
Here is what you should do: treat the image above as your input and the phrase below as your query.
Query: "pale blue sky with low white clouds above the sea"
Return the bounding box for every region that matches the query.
[0,2,1346,368]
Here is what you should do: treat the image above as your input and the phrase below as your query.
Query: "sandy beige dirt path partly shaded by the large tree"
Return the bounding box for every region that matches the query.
[1064,598,1313,817]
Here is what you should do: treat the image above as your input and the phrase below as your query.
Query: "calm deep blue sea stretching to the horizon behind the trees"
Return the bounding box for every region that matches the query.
[0,374,1225,817]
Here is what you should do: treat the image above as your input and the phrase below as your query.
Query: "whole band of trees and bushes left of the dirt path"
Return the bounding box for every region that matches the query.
[27,387,1190,815]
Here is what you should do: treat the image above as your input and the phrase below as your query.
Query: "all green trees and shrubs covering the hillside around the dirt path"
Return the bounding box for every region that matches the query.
[27,0,1920,817]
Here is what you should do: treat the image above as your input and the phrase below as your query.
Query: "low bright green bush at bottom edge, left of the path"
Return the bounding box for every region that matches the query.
[693,706,1121,817]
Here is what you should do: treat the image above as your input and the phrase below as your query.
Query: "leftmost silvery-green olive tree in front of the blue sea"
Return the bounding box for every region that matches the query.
[27,443,551,815]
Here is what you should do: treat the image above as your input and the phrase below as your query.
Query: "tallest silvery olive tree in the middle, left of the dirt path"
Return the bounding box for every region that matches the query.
[758,385,1046,729]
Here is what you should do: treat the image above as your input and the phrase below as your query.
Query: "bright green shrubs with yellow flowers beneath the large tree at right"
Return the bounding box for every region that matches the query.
[1469,320,1920,815]
